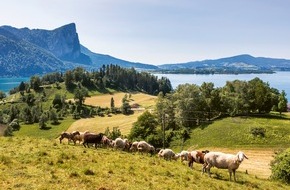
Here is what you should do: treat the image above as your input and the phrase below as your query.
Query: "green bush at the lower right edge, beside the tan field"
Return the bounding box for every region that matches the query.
[270,148,290,184]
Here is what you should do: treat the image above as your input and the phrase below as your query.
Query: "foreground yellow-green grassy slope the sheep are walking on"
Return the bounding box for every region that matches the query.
[0,137,289,190]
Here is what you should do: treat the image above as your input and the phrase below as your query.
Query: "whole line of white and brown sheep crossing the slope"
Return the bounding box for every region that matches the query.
[59,131,248,181]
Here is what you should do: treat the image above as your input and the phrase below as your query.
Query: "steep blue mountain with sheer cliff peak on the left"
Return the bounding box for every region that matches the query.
[0,23,157,77]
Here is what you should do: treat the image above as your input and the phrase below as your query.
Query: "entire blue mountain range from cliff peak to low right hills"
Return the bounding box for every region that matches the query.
[0,23,290,77]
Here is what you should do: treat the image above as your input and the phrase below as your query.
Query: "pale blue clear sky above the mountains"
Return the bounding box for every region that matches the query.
[0,0,290,65]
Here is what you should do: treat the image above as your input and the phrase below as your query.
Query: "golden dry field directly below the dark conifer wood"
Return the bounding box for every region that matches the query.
[85,92,157,108]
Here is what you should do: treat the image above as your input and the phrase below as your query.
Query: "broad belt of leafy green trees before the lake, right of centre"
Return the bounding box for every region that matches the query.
[129,78,287,147]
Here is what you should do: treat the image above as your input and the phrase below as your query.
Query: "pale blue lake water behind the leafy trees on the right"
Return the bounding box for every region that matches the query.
[154,71,290,103]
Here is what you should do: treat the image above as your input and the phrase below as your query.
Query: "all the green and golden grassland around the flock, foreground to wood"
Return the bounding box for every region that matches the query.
[0,88,290,190]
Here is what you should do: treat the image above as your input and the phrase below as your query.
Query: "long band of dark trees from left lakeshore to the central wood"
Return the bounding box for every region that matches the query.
[10,64,172,95]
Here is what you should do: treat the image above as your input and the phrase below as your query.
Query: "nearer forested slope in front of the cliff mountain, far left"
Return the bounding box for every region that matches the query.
[0,31,66,76]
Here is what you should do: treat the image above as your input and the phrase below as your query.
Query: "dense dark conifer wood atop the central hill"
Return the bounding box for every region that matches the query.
[64,64,172,95]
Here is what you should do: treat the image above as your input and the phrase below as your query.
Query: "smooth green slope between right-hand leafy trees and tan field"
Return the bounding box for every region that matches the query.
[174,117,290,148]
